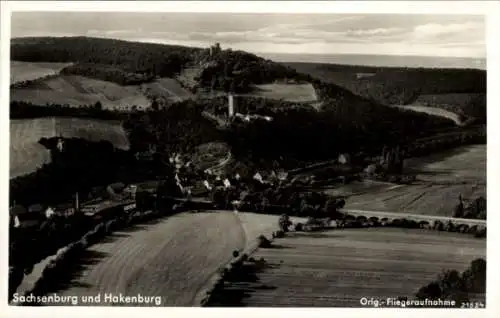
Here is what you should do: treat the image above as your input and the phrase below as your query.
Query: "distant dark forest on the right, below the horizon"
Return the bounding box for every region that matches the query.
[284,63,486,123]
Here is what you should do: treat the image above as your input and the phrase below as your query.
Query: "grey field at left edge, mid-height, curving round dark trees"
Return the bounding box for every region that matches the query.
[10,118,129,178]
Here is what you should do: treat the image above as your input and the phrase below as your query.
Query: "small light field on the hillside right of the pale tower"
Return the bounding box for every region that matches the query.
[250,84,318,103]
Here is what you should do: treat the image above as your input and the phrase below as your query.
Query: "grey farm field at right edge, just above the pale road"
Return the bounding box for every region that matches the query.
[346,145,486,216]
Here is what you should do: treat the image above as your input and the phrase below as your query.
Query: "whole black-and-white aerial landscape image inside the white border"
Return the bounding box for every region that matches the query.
[2,1,493,316]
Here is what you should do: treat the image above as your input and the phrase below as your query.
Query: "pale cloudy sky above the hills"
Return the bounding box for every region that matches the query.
[11,12,486,58]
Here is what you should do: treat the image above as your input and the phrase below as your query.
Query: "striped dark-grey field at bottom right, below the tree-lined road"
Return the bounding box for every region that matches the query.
[209,228,486,307]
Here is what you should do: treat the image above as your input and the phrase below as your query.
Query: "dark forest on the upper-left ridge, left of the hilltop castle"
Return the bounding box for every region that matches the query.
[10,36,197,77]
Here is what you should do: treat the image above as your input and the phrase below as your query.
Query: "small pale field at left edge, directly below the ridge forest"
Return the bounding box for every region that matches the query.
[10,61,72,85]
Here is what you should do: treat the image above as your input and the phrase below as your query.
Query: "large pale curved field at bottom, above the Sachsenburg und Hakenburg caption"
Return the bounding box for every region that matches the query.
[43,212,276,306]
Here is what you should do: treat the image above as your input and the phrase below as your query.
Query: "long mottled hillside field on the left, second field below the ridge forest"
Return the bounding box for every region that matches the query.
[10,76,151,109]
